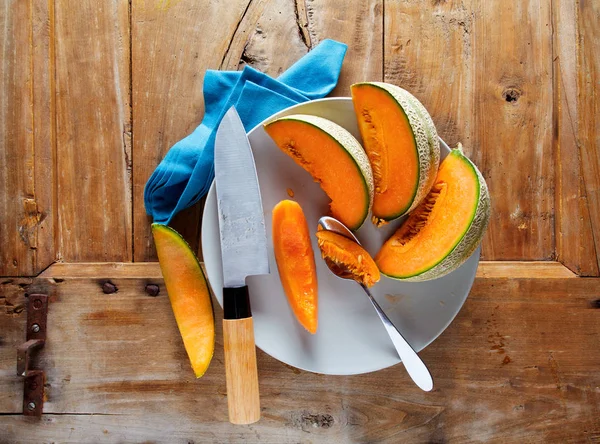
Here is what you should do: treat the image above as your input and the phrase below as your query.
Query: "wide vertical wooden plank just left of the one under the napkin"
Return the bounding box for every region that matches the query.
[55,0,132,261]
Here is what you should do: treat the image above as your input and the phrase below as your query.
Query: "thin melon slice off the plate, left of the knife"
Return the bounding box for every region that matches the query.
[152,224,215,378]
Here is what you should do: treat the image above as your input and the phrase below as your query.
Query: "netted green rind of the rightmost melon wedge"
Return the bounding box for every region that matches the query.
[394,145,491,282]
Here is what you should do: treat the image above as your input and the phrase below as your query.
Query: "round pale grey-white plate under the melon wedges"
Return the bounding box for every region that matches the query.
[202,98,480,375]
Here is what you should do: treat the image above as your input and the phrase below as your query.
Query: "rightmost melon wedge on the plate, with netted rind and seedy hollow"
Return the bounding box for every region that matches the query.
[375,144,490,281]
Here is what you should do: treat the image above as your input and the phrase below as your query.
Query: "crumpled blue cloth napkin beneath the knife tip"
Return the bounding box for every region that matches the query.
[144,40,347,224]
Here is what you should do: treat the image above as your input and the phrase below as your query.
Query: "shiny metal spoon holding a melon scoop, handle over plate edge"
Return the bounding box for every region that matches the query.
[319,216,433,392]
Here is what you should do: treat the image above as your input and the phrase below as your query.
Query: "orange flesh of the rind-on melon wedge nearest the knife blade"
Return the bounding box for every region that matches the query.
[265,119,370,230]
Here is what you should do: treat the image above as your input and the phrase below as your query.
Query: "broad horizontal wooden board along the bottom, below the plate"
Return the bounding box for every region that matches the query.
[0,276,600,443]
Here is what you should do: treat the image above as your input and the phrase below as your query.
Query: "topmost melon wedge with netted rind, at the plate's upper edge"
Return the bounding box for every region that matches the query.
[351,82,440,226]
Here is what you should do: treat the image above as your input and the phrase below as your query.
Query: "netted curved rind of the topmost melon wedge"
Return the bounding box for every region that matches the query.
[352,82,440,222]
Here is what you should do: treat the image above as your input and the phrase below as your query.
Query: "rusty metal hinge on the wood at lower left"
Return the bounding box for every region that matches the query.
[17,294,48,416]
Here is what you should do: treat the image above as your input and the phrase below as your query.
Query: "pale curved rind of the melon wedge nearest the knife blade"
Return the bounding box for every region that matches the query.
[265,114,375,231]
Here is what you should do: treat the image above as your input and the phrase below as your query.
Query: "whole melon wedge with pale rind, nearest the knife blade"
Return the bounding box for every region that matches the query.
[265,114,373,230]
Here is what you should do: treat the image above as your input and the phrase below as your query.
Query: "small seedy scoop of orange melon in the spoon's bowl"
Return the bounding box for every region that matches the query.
[317,230,381,287]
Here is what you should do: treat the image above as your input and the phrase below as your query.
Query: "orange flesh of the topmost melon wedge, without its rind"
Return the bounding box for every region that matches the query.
[352,84,419,220]
